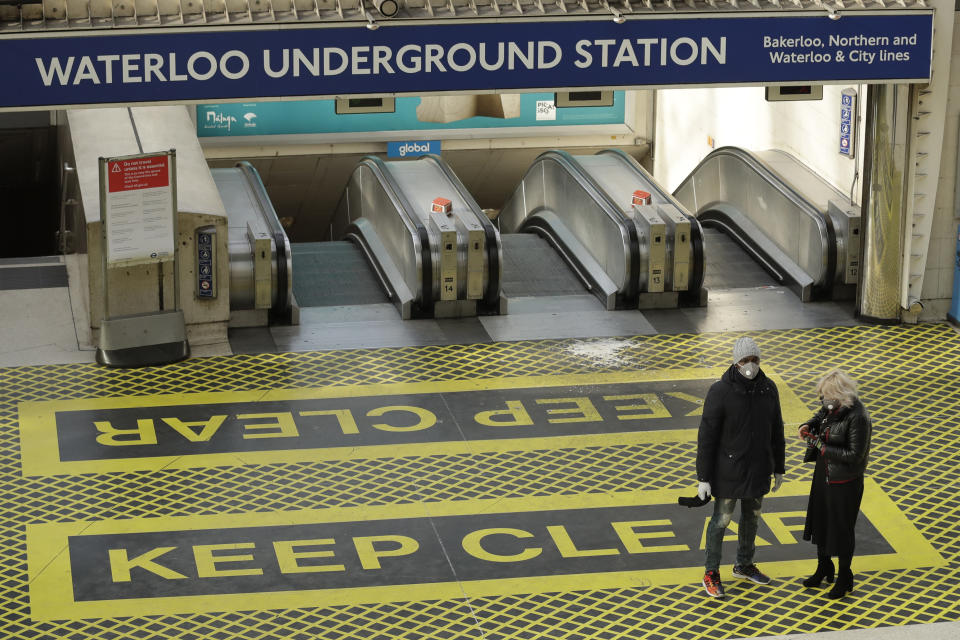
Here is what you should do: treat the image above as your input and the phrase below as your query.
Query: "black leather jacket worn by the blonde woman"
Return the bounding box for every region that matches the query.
[803,400,873,482]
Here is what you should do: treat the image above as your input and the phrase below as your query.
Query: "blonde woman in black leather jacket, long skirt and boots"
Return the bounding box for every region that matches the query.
[800,369,872,599]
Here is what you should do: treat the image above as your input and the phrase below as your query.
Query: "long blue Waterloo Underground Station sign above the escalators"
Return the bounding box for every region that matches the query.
[0,11,933,108]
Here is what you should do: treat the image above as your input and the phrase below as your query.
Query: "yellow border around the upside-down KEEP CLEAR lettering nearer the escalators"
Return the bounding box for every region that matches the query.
[18,367,810,476]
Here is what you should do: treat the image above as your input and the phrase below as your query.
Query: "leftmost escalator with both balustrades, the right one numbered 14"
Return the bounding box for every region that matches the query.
[218,156,501,326]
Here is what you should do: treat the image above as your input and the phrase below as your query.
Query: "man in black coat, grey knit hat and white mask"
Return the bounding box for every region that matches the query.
[697,337,784,598]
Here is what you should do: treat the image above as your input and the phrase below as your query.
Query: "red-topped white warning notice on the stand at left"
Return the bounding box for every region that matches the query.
[102,153,175,263]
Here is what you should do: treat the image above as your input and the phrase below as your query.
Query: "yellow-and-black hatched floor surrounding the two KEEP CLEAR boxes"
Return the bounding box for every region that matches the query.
[0,325,960,640]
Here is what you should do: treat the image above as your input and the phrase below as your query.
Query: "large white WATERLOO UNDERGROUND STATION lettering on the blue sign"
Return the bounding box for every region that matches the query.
[34,36,727,87]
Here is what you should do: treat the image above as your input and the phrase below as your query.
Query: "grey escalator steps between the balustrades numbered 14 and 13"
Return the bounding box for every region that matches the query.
[500,233,585,298]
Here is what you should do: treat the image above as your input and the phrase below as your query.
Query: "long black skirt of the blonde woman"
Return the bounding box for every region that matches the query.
[803,455,863,556]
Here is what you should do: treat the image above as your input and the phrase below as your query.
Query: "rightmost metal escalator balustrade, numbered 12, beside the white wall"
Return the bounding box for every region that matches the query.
[674,147,860,302]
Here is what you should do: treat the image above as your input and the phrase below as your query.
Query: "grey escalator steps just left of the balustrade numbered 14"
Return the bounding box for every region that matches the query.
[291,241,390,307]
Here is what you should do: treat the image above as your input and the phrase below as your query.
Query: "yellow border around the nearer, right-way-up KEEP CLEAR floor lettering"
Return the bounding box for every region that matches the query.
[27,478,946,620]
